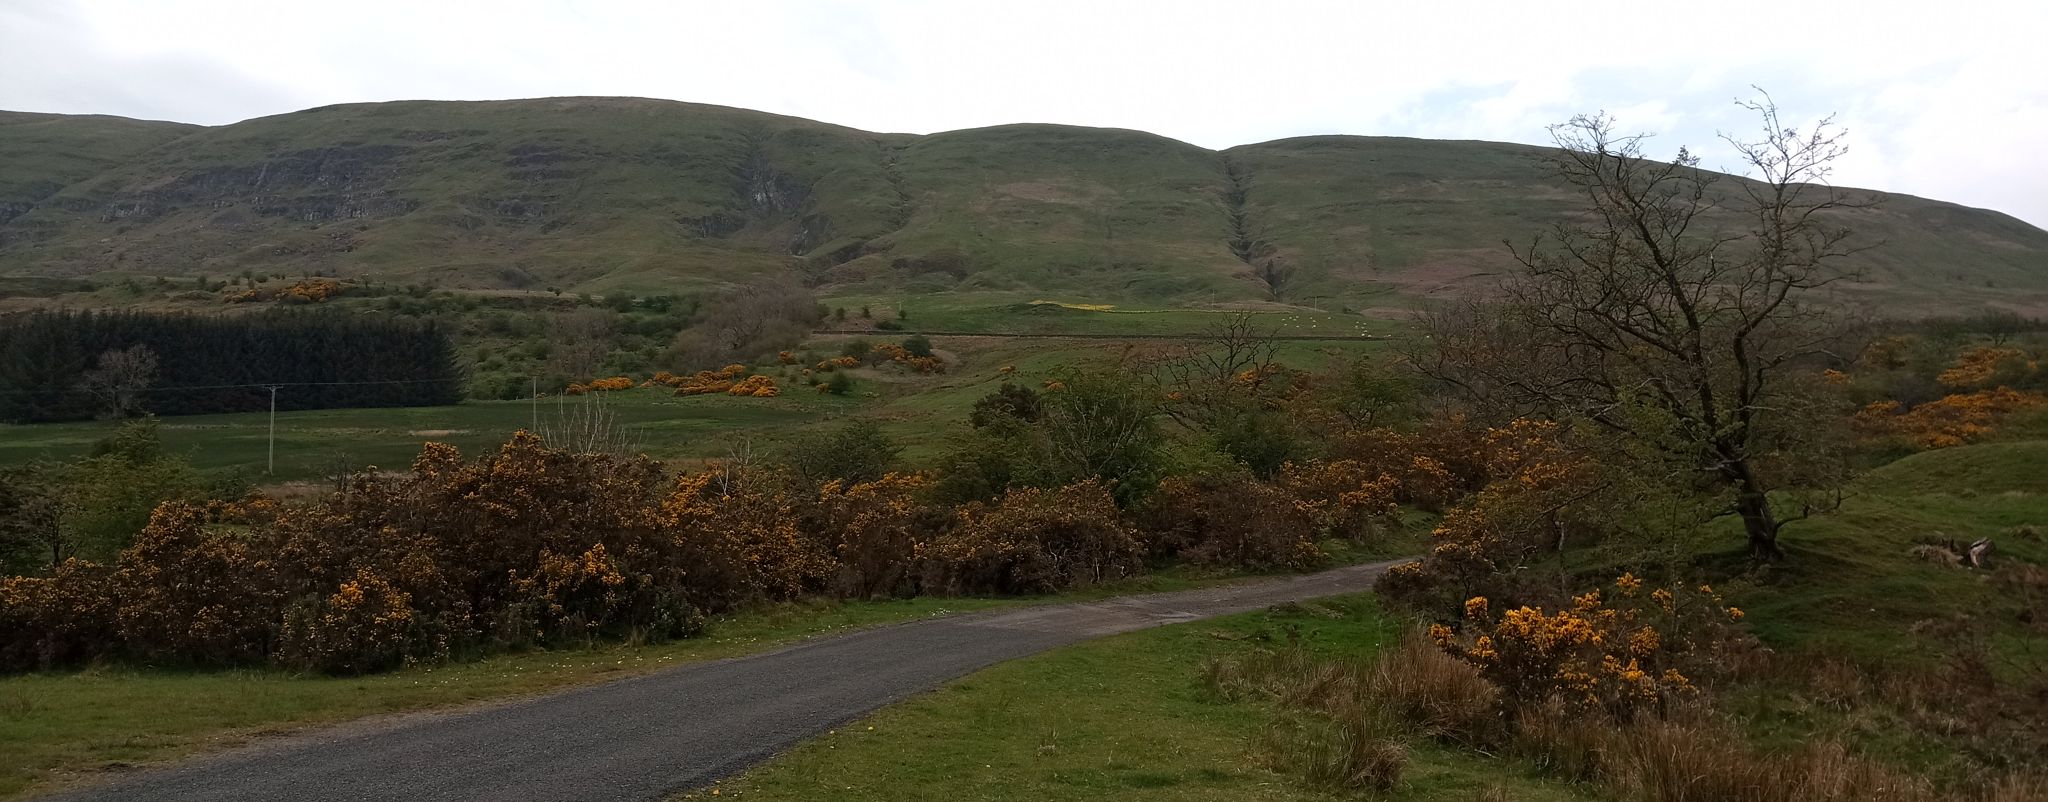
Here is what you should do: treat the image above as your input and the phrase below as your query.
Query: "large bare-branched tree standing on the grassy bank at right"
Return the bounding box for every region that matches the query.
[1421,98,1864,559]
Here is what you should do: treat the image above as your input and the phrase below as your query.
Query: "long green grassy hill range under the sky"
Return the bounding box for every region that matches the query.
[0,98,2048,311]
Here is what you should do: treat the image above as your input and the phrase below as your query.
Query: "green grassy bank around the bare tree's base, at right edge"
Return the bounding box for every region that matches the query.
[1589,435,2048,782]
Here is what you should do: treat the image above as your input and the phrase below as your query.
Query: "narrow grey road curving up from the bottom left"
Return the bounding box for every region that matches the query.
[51,563,1391,802]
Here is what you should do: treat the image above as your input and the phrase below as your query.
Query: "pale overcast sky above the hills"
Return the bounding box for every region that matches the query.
[0,0,2048,227]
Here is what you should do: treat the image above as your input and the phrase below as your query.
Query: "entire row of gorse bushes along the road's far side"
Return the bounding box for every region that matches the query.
[0,426,1433,673]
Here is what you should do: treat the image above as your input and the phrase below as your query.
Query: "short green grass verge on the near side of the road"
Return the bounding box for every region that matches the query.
[712,595,1581,802]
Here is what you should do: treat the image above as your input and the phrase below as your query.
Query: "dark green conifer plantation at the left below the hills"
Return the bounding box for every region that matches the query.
[0,311,463,424]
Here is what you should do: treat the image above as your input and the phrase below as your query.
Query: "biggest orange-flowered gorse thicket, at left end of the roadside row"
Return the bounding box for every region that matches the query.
[0,434,770,673]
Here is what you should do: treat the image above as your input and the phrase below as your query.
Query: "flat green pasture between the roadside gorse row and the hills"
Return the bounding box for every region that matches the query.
[0,323,1399,483]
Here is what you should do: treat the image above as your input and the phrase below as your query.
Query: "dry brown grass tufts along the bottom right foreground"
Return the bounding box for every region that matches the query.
[1204,632,2048,802]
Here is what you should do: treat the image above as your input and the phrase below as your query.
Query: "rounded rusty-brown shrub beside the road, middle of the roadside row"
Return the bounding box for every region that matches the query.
[933,481,1145,593]
